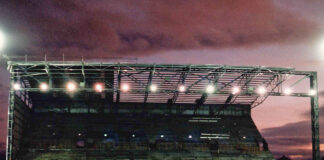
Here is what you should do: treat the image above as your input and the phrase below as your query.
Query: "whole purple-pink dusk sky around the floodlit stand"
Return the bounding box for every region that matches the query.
[0,0,324,159]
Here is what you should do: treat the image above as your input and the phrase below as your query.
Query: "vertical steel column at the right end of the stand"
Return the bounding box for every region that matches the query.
[310,72,321,160]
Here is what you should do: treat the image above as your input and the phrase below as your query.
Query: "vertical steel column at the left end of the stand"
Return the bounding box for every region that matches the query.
[6,80,15,160]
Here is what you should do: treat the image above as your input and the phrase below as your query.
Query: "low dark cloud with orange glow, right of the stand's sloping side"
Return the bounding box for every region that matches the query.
[261,107,324,159]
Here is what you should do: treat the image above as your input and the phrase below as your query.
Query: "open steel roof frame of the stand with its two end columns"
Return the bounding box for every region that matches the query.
[7,61,320,160]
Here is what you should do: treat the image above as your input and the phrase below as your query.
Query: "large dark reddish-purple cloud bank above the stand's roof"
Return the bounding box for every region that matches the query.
[0,0,316,56]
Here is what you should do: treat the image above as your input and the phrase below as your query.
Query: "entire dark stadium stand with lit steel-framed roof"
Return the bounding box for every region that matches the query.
[7,62,319,160]
